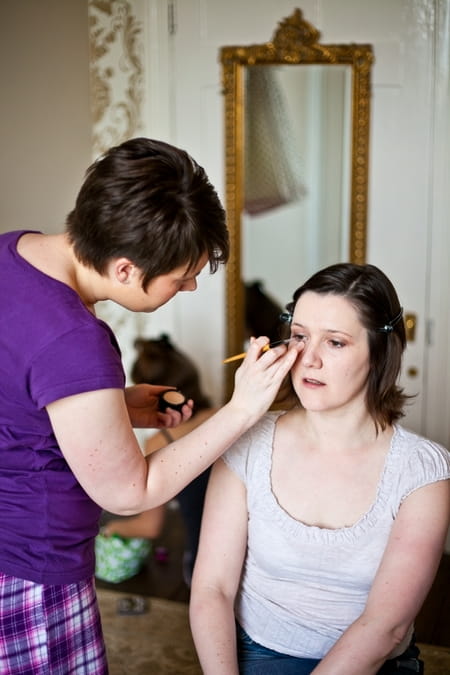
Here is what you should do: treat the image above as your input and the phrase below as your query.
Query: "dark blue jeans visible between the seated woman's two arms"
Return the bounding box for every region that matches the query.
[237,625,320,675]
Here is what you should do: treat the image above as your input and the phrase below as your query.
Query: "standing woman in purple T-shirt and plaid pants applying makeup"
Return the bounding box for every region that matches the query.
[0,138,296,675]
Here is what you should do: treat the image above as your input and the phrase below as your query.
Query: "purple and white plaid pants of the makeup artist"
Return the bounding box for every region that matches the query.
[0,573,108,675]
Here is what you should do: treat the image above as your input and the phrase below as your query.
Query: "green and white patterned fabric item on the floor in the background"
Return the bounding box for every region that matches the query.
[95,534,152,584]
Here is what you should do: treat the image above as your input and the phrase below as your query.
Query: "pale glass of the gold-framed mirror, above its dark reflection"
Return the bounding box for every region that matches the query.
[241,60,351,306]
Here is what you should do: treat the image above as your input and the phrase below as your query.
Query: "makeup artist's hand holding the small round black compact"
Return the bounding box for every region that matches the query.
[125,384,194,429]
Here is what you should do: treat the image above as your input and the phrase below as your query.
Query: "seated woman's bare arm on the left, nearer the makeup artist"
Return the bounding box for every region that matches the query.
[190,460,248,675]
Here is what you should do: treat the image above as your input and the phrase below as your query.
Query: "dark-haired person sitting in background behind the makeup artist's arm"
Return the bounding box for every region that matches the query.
[101,335,217,585]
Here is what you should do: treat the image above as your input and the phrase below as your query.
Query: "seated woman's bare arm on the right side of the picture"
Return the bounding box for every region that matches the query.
[313,481,450,675]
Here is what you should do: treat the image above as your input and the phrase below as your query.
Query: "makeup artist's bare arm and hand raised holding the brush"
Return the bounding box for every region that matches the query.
[47,338,299,515]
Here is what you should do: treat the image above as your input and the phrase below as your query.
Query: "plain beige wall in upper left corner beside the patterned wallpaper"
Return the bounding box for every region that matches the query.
[0,0,91,232]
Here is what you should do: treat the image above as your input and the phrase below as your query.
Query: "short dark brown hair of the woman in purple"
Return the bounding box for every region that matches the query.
[66,138,229,289]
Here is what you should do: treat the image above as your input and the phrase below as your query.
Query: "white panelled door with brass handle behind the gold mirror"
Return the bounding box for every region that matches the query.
[153,0,450,444]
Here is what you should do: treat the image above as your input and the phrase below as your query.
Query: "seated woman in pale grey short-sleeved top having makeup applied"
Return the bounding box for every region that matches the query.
[190,263,450,675]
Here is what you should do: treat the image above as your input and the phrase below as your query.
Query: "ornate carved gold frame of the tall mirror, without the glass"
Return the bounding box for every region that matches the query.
[220,9,373,399]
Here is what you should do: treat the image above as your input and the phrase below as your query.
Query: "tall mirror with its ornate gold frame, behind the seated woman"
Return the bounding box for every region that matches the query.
[220,9,373,398]
